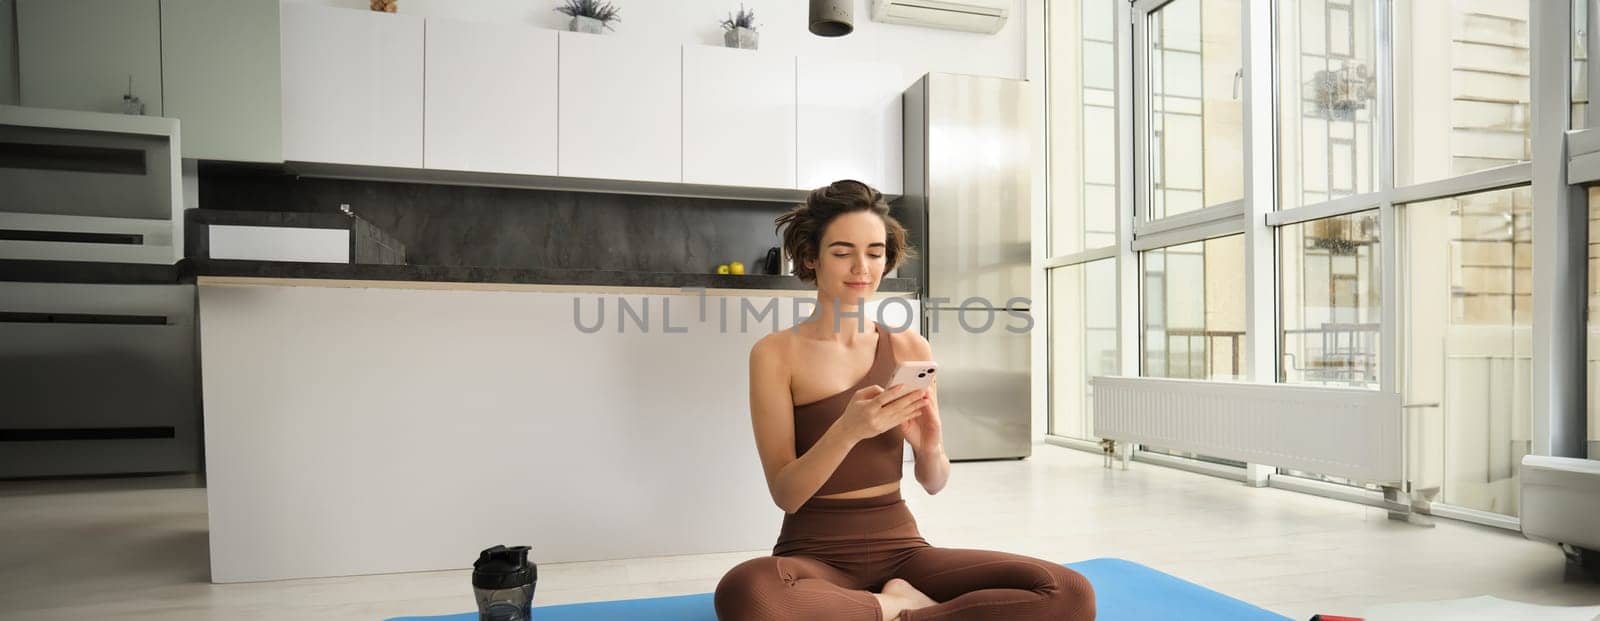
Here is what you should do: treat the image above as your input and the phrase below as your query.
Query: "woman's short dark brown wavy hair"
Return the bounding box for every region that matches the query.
[776,179,917,283]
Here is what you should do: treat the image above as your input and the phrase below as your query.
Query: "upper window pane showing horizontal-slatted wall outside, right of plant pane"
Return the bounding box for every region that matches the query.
[1392,0,1531,186]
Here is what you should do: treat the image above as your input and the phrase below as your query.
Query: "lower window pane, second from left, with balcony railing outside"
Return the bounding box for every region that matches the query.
[1141,235,1248,379]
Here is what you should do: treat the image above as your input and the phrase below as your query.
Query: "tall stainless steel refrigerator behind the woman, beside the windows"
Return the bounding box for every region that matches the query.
[894,74,1043,459]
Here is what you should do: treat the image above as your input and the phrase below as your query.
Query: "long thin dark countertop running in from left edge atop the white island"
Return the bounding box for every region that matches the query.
[0,258,917,293]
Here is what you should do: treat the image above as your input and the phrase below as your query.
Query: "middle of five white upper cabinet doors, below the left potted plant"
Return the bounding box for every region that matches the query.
[558,32,683,182]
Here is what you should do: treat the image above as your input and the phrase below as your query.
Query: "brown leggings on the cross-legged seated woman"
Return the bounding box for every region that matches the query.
[714,490,1094,621]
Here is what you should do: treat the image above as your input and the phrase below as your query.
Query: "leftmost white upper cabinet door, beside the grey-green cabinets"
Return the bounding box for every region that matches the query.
[282,3,422,168]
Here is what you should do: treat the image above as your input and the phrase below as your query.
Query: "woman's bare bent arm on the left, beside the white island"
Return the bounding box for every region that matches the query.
[750,335,856,514]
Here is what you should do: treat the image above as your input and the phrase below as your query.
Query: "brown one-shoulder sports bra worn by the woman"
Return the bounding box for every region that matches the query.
[795,322,906,496]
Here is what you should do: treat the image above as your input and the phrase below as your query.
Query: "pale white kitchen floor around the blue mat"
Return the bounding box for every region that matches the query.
[0,445,1600,621]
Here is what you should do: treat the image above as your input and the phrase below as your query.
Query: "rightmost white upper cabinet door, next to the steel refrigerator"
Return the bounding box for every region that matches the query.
[795,56,910,194]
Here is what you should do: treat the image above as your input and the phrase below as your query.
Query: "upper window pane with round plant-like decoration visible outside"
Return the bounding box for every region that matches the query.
[1277,0,1379,208]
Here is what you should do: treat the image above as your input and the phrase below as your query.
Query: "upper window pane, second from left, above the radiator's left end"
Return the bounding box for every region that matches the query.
[1146,0,1245,219]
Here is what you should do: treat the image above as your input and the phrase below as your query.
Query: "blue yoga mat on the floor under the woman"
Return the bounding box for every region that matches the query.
[387,559,1290,621]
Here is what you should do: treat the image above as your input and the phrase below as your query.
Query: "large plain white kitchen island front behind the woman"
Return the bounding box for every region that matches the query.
[189,261,918,583]
